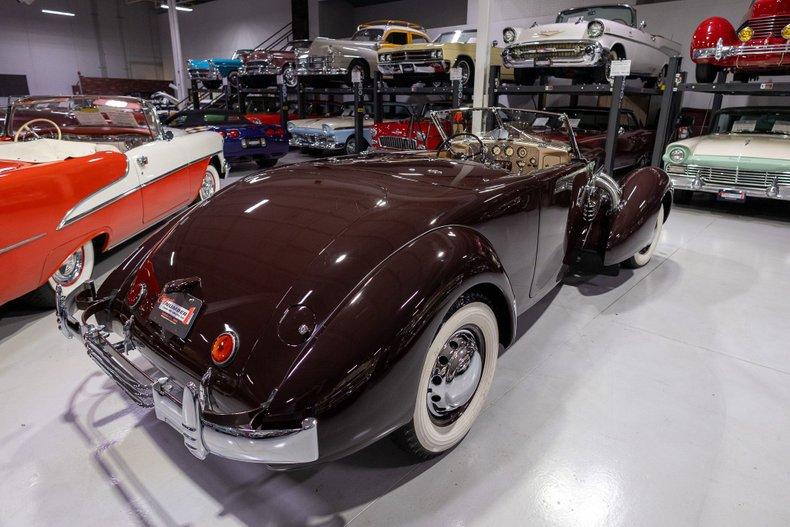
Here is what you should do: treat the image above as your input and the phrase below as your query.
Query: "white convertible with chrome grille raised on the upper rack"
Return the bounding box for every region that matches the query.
[502,4,680,84]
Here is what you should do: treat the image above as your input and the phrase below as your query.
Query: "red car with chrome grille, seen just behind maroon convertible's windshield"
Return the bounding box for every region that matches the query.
[372,102,449,150]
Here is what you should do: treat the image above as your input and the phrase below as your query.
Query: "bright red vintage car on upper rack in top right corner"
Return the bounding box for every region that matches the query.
[691,0,790,82]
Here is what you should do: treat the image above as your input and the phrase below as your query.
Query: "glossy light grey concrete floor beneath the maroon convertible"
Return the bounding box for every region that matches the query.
[0,156,790,527]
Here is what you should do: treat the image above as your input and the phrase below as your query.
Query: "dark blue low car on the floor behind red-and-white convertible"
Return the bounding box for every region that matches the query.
[164,109,288,168]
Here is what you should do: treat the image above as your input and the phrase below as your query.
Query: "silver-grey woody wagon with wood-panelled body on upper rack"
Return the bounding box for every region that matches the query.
[296,20,430,84]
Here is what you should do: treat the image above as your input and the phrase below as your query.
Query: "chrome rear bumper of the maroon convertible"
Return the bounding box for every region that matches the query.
[55,281,318,465]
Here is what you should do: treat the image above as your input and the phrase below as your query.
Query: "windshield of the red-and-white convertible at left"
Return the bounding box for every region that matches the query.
[8,95,158,141]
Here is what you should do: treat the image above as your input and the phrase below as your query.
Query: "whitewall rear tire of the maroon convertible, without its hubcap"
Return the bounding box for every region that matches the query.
[405,301,499,457]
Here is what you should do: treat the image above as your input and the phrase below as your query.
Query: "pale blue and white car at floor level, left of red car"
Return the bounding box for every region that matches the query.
[288,103,412,154]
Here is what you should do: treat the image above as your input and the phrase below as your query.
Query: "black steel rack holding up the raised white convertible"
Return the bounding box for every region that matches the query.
[488,57,681,174]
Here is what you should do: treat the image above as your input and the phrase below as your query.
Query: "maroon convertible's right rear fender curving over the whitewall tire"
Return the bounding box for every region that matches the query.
[269,226,516,460]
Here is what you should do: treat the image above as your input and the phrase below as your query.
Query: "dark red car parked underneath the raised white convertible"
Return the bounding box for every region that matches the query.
[552,106,656,174]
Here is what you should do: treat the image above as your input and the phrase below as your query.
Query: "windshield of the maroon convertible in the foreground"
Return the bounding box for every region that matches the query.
[431,108,581,157]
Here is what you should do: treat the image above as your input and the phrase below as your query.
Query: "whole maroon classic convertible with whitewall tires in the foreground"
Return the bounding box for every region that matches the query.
[57,108,672,468]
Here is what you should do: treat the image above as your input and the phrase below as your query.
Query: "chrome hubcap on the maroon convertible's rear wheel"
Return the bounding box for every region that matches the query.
[427,326,484,419]
